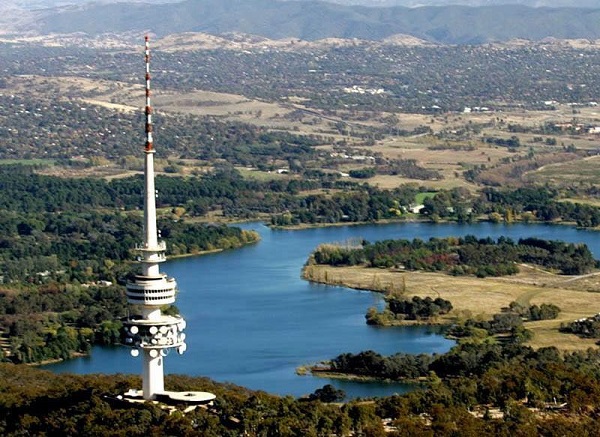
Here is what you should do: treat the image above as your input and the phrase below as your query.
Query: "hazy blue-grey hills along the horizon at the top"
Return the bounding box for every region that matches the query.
[4,0,600,44]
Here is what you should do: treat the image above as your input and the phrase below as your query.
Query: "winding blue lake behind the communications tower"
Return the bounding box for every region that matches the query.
[46,223,600,397]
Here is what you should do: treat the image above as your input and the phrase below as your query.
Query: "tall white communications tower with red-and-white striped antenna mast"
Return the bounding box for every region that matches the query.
[123,36,206,401]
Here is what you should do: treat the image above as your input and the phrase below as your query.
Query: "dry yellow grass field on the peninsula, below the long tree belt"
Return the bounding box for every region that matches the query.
[306,265,600,351]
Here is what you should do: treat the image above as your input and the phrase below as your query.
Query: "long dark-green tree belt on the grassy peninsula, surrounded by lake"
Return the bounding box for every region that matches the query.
[309,235,596,277]
